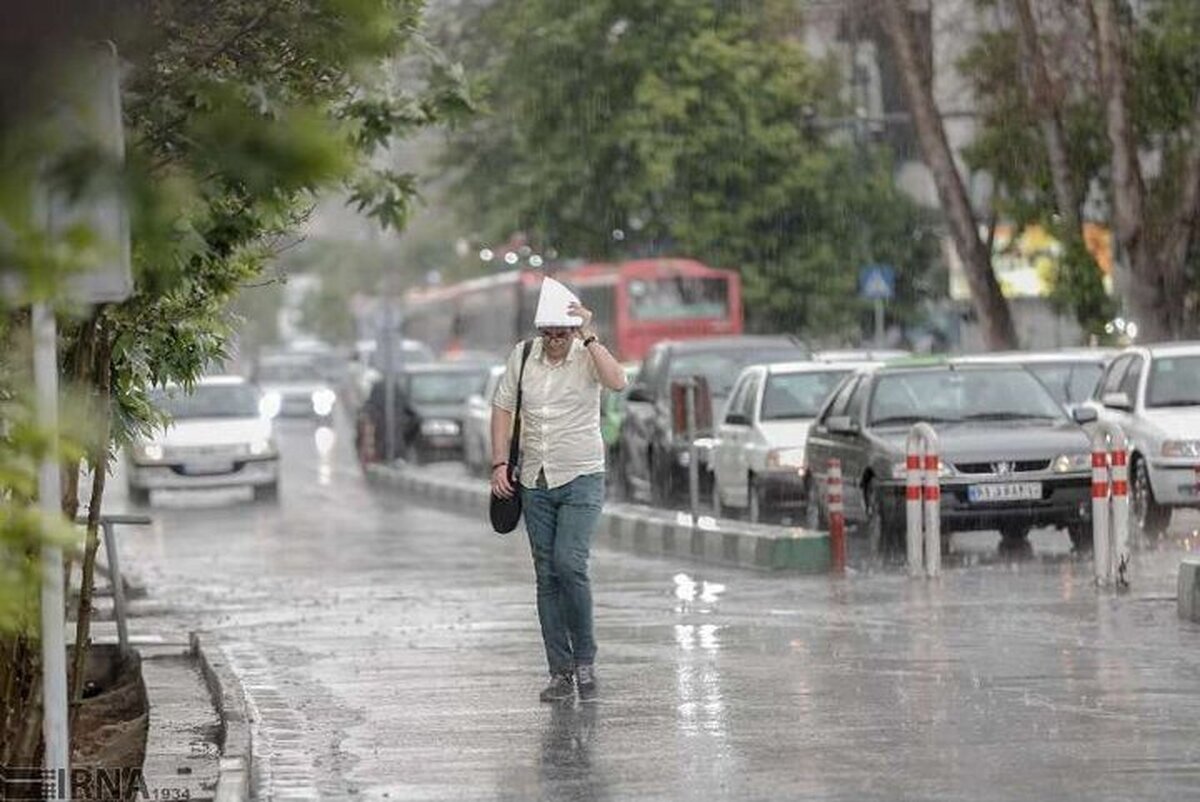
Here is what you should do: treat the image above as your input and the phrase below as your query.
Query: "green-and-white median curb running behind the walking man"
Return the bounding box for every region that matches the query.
[367,465,833,574]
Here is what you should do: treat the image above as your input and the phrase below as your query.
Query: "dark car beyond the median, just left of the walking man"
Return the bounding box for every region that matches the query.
[355,363,491,463]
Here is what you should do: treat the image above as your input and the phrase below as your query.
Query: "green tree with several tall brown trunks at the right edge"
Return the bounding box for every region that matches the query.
[961,0,1200,340]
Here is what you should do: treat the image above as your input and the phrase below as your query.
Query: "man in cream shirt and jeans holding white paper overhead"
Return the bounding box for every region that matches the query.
[492,279,625,702]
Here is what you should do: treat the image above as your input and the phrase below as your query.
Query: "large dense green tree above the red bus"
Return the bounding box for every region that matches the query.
[449,0,935,336]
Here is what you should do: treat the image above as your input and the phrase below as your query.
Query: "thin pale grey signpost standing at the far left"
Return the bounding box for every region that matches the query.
[32,304,71,778]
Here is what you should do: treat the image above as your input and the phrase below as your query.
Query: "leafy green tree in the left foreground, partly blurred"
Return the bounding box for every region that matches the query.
[0,0,469,765]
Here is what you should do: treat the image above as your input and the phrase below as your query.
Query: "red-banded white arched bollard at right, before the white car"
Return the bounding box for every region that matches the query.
[1092,421,1129,585]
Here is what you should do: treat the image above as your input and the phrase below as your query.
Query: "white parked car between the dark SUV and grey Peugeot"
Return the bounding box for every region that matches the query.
[712,361,868,522]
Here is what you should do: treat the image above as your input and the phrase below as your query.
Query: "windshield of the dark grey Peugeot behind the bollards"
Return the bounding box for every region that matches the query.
[870,367,1064,426]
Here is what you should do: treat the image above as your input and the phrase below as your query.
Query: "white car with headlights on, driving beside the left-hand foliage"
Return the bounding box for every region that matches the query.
[126,376,280,504]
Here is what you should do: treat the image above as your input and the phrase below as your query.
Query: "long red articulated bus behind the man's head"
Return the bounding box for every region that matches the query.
[401,259,742,361]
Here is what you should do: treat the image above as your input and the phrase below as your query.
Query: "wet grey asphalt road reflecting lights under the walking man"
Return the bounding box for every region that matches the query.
[109,421,1200,801]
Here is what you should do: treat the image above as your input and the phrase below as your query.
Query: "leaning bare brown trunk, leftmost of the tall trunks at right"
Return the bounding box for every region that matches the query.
[878,0,1018,351]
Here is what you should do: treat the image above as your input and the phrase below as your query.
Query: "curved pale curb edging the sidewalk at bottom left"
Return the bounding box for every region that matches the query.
[188,632,253,802]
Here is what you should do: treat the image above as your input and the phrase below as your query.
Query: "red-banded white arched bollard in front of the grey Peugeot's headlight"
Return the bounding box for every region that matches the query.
[905,423,942,577]
